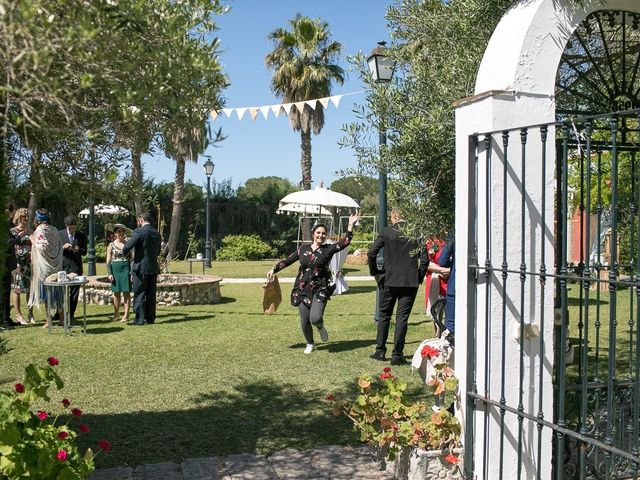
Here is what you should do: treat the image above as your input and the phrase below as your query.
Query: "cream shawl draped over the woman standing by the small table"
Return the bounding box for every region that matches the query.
[29,223,63,309]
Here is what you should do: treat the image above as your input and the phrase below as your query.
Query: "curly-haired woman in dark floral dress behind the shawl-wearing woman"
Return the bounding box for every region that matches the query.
[11,208,36,325]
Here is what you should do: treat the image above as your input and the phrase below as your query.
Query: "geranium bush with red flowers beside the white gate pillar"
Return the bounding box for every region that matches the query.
[327,347,462,464]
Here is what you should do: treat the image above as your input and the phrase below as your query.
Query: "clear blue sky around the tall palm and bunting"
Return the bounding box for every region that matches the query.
[144,0,392,188]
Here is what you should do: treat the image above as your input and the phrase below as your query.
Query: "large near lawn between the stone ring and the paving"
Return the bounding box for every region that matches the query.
[0,280,433,467]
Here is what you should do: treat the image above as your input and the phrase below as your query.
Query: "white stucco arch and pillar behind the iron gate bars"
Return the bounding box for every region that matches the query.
[455,0,640,480]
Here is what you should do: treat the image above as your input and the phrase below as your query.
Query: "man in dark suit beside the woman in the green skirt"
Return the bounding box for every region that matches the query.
[122,212,162,325]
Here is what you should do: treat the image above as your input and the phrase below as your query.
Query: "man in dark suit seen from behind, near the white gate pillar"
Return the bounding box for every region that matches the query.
[368,208,429,365]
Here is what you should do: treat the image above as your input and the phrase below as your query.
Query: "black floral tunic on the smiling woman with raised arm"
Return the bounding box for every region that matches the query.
[273,232,353,307]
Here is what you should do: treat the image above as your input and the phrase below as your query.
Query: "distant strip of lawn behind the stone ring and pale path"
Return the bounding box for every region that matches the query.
[84,259,369,278]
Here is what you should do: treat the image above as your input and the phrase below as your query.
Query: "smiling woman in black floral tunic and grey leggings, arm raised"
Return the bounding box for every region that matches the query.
[267,215,360,354]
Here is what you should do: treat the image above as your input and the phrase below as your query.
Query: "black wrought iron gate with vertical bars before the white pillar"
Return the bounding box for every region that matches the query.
[465,110,640,480]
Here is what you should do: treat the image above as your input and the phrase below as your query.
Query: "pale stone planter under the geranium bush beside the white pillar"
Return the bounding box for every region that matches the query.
[383,447,464,480]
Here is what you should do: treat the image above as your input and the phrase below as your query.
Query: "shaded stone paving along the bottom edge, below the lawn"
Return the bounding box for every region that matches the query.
[91,446,393,480]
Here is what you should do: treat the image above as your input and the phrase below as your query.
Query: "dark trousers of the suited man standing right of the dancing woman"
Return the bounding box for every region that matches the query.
[376,285,418,360]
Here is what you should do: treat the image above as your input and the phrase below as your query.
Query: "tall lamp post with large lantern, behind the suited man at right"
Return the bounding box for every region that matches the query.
[367,42,396,322]
